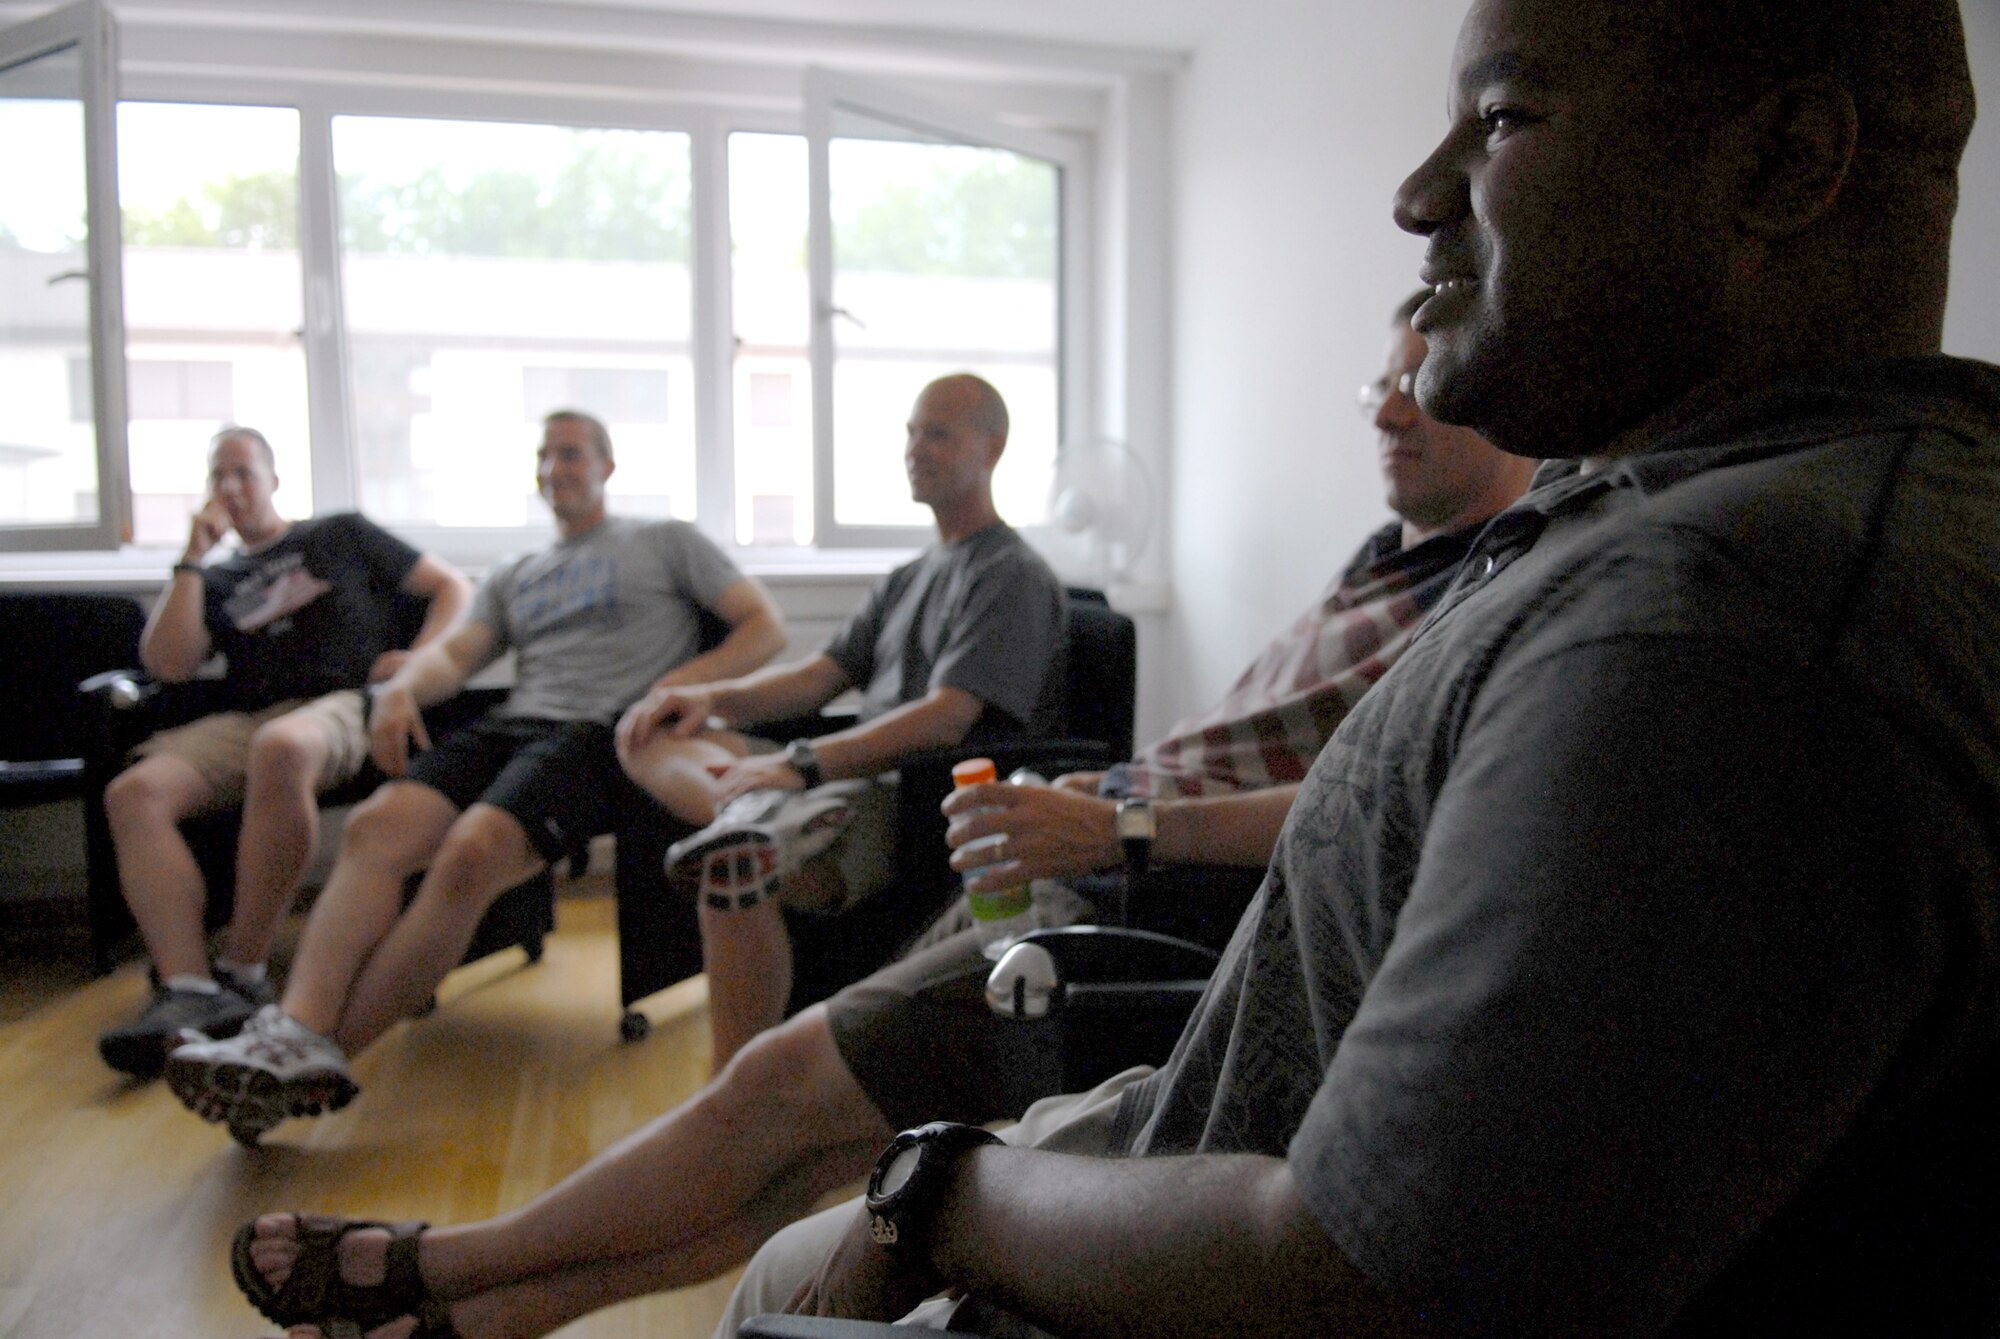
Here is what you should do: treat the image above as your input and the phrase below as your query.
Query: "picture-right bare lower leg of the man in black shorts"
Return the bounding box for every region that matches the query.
[332,803,546,1055]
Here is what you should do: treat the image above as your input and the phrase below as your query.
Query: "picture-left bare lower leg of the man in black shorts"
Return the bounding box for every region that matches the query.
[282,781,458,1035]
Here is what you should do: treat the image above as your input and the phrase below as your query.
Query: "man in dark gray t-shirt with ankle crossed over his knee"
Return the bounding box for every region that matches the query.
[618,374,1064,1069]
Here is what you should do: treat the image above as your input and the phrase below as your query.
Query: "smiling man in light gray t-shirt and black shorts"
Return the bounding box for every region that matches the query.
[168,410,784,1139]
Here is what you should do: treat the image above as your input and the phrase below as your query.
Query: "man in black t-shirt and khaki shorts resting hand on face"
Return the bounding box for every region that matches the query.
[98,428,470,1077]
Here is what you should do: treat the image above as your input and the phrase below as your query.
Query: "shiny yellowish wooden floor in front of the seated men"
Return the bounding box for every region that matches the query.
[0,891,734,1339]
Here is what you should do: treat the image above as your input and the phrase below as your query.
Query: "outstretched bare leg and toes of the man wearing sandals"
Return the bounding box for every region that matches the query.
[236,1019,894,1339]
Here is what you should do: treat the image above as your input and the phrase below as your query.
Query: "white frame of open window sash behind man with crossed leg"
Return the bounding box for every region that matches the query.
[806,66,1096,550]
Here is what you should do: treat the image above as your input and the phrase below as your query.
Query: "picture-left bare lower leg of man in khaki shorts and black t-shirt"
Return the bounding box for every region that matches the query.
[104,753,218,979]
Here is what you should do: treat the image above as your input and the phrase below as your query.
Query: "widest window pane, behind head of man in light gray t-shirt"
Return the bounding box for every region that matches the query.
[334,116,696,526]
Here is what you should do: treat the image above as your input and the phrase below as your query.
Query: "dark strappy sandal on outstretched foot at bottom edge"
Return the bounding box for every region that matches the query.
[230,1213,458,1339]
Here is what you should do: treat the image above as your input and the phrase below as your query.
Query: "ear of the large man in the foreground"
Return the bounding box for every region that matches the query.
[1738,74,1860,238]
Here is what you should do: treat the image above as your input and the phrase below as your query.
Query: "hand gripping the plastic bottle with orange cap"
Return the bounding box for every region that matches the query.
[944,781,1124,893]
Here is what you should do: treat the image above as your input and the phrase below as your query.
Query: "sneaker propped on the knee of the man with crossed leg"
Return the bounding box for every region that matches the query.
[666,789,854,911]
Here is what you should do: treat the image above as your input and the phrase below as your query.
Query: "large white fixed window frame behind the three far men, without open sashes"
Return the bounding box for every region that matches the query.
[0,0,1184,584]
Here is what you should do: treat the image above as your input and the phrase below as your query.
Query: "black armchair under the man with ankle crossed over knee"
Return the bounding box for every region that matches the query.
[616,588,1138,1039]
